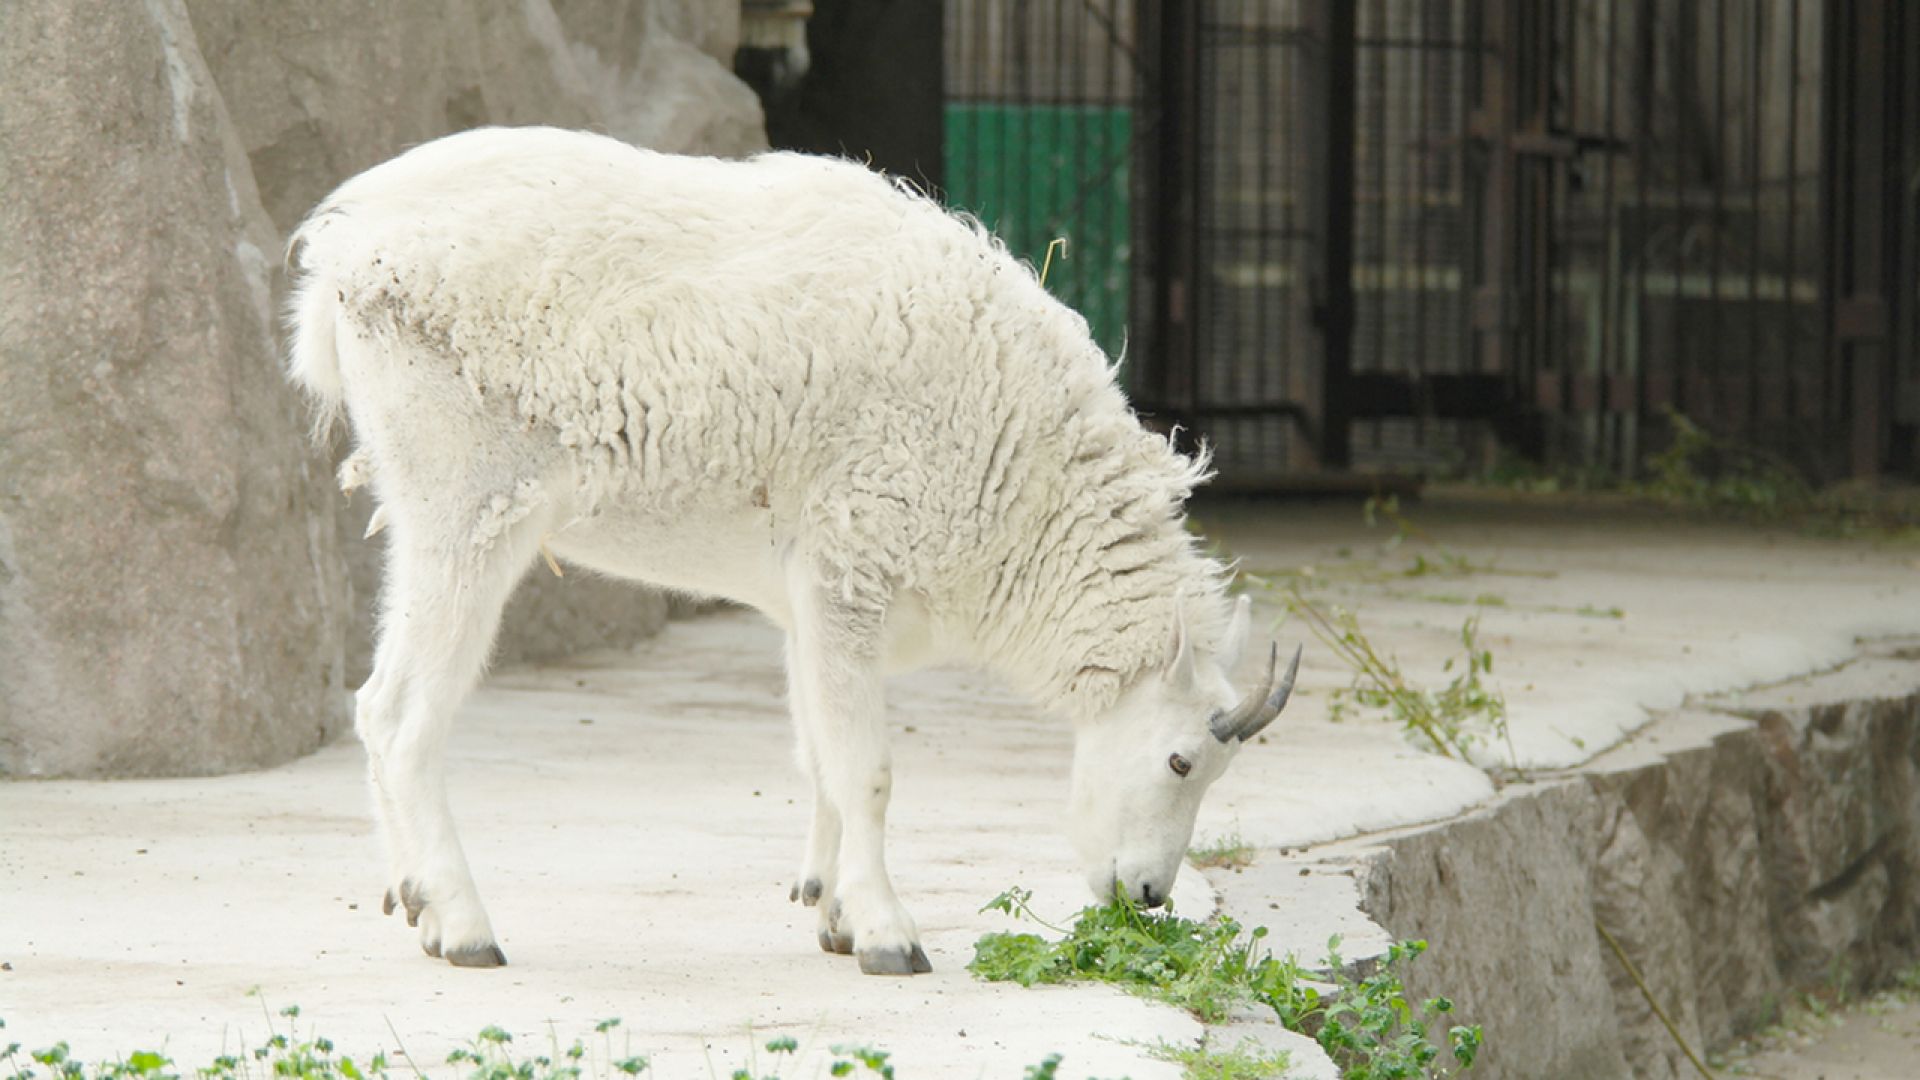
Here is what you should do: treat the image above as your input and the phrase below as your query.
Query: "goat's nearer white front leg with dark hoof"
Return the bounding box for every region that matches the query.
[787,561,931,974]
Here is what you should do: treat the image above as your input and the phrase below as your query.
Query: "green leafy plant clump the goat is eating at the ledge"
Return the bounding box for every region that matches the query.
[968,888,1482,1080]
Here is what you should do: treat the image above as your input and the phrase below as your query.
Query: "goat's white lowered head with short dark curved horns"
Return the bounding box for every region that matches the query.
[1071,596,1300,907]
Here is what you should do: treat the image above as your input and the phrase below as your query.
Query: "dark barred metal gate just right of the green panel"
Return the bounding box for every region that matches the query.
[1133,0,1513,478]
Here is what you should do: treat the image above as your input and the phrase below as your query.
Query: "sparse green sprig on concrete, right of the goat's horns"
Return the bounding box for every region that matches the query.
[1286,590,1513,763]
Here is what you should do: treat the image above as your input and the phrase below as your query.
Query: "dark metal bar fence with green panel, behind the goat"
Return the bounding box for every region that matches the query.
[945,0,1920,484]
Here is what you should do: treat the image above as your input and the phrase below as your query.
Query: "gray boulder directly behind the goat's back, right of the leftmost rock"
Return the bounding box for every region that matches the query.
[190,0,766,672]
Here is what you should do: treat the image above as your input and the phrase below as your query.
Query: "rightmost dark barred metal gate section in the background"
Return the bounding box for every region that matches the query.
[1476,0,1920,479]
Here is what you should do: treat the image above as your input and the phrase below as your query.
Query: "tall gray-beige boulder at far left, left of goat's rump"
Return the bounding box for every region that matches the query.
[0,0,348,776]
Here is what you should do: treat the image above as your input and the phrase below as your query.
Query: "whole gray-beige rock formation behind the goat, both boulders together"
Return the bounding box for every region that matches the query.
[0,0,764,776]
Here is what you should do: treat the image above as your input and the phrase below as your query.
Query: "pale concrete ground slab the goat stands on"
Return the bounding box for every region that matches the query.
[0,500,1920,1080]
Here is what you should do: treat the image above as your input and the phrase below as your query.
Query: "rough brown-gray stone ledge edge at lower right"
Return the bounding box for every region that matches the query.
[1297,650,1920,1078]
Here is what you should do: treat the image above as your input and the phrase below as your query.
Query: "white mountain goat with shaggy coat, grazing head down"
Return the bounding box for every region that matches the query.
[290,129,1298,974]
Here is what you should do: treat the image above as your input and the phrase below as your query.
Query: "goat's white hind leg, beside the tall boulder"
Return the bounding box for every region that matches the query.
[355,513,543,967]
